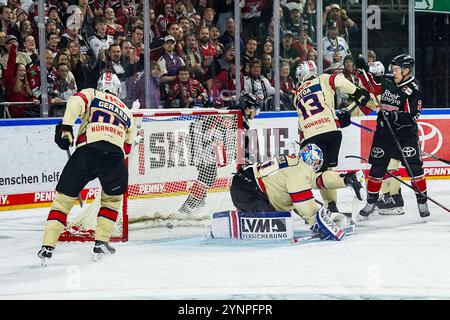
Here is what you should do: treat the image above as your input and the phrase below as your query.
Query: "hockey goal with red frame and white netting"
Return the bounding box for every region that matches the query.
[60,109,243,241]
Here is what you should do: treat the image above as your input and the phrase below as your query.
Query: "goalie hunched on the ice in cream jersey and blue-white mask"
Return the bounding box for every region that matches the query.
[224,144,361,240]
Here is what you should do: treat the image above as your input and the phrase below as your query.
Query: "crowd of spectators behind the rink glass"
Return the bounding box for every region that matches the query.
[0,0,384,117]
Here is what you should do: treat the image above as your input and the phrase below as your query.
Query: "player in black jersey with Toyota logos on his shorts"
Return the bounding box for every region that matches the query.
[356,54,430,218]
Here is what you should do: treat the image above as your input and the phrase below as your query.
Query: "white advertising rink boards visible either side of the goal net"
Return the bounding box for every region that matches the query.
[0,109,450,210]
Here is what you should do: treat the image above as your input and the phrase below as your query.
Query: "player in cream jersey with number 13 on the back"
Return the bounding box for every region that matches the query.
[294,61,370,212]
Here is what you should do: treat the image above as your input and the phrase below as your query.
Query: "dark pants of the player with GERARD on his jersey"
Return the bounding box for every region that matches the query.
[56,142,128,197]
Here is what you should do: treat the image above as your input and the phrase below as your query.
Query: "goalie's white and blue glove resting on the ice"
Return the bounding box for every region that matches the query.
[311,206,347,241]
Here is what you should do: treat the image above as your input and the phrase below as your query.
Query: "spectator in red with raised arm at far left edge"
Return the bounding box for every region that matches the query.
[5,43,39,118]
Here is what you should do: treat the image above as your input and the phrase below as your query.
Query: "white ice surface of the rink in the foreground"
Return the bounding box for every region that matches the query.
[0,180,450,299]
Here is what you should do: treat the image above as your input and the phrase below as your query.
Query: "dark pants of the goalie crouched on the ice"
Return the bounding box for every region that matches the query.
[230,167,276,212]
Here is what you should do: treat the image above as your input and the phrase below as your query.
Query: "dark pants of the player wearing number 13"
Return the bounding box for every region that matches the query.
[301,130,342,172]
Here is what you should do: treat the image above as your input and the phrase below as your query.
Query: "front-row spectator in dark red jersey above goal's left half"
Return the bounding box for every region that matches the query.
[169,66,208,108]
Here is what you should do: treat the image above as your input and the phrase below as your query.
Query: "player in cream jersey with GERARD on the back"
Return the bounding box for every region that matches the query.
[38,72,136,265]
